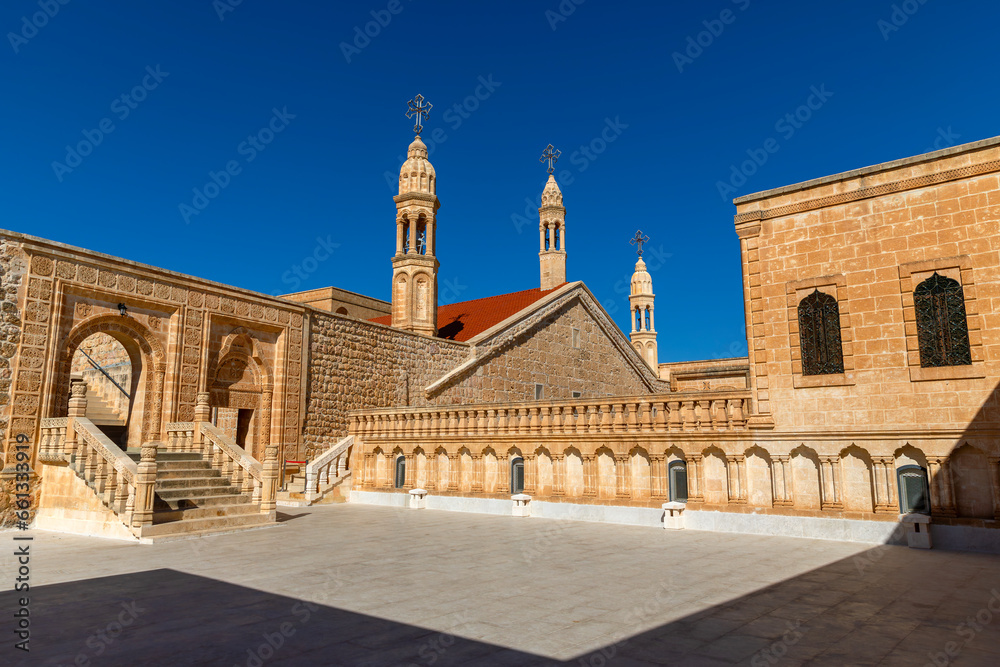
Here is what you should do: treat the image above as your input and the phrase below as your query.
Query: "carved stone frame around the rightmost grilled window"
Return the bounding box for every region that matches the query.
[899,255,986,382]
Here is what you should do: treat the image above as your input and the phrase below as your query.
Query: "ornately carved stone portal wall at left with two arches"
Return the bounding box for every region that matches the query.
[0,230,307,470]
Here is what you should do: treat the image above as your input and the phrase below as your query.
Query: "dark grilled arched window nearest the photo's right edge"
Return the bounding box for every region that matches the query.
[913,273,972,368]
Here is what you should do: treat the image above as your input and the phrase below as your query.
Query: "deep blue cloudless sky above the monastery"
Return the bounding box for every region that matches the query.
[0,0,1000,361]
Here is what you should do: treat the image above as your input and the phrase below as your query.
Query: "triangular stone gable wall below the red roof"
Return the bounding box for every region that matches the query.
[434,299,649,404]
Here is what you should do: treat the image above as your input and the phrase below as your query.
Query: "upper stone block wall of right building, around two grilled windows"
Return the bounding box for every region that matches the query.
[737,145,1000,430]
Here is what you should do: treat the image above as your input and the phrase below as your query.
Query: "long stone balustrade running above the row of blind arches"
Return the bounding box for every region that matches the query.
[350,390,750,440]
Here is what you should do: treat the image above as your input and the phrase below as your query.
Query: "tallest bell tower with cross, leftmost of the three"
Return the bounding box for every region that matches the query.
[392,95,441,336]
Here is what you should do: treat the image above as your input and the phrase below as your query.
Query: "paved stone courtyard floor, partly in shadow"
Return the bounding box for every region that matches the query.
[0,505,1000,667]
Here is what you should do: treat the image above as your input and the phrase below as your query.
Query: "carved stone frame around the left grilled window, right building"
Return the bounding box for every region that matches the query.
[785,274,854,389]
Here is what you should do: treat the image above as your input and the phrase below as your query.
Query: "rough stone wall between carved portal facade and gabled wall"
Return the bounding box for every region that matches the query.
[303,311,473,458]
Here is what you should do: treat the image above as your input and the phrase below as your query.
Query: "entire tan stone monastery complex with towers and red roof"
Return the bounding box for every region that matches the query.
[0,126,1000,550]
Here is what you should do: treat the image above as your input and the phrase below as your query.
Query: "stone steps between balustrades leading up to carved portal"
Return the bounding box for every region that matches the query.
[128,449,274,542]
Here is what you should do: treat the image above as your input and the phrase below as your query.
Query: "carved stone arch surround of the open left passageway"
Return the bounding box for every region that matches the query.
[50,315,166,447]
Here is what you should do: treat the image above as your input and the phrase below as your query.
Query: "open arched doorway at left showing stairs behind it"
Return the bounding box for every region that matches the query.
[70,333,134,448]
